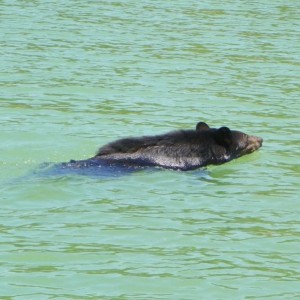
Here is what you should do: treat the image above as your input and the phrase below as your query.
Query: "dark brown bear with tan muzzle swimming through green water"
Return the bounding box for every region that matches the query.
[62,122,263,171]
